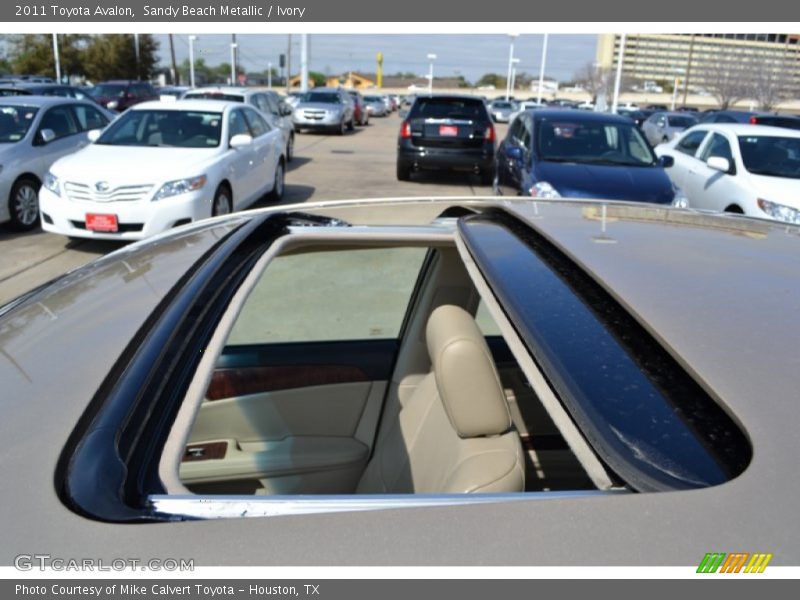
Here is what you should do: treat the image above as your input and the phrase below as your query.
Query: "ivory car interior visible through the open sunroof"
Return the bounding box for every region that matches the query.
[162,234,598,496]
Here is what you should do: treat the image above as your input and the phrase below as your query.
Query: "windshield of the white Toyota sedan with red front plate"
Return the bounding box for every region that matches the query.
[96,110,222,148]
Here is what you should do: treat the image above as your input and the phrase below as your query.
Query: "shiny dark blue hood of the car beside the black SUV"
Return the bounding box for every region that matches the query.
[535,162,674,204]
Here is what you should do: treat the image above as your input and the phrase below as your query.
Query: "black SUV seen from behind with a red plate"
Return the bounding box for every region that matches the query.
[397,96,495,185]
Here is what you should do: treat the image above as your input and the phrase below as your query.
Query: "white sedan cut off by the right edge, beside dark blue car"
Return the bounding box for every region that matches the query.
[655,123,800,224]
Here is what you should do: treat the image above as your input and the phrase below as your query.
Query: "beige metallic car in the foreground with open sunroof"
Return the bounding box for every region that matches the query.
[0,198,800,578]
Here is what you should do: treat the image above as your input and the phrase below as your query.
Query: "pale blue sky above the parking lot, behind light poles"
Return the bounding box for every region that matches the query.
[155,34,597,83]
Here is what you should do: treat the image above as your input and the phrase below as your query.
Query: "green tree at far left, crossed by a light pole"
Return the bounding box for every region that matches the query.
[9,34,87,77]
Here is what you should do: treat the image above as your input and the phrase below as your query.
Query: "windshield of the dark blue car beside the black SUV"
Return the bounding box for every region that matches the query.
[536,121,656,167]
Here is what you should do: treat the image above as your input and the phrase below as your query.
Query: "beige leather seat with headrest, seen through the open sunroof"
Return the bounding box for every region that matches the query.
[357,305,525,494]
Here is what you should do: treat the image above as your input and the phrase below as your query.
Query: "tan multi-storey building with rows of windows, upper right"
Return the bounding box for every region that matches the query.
[597,33,800,91]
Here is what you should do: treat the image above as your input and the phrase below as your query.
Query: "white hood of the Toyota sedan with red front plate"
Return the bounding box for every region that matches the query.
[50,144,219,186]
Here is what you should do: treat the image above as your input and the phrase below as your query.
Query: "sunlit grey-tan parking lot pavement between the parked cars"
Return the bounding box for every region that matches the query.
[0,113,506,304]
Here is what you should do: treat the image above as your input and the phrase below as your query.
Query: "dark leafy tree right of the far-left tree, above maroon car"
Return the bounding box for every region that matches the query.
[83,34,158,81]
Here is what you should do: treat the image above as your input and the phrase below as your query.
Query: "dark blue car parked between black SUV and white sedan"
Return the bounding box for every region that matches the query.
[493,109,682,204]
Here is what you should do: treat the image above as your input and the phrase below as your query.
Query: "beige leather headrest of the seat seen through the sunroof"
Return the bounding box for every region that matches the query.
[426,305,511,438]
